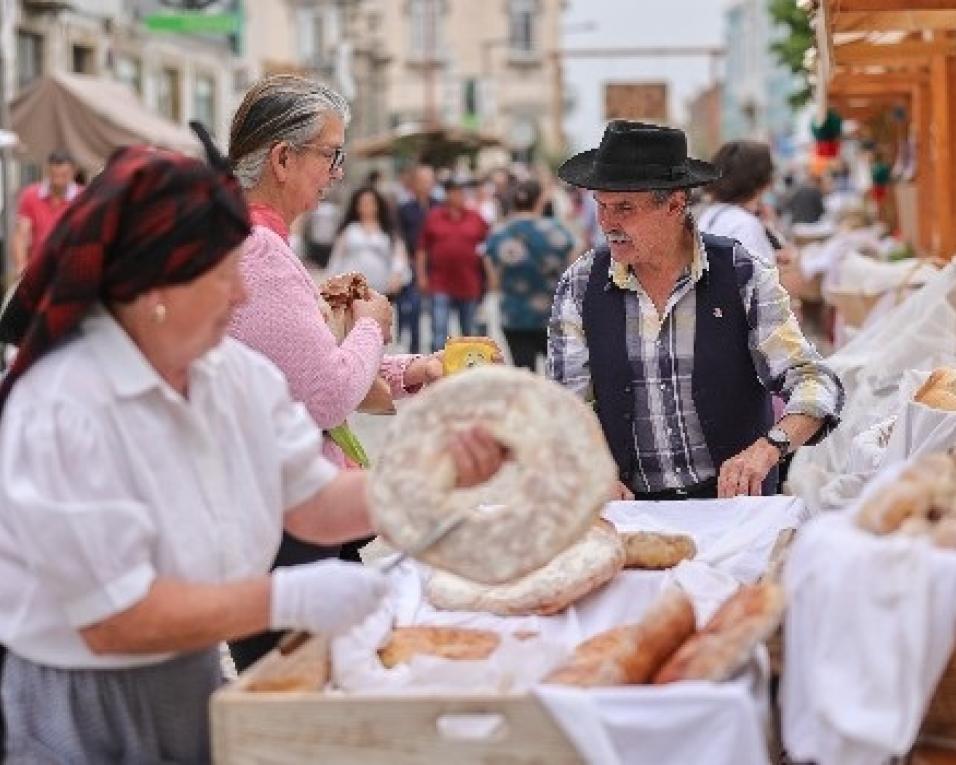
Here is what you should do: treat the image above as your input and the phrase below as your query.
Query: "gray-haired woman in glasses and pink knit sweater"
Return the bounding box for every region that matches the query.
[229,75,442,669]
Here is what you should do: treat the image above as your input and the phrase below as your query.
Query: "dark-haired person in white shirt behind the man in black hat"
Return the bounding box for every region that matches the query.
[698,141,793,264]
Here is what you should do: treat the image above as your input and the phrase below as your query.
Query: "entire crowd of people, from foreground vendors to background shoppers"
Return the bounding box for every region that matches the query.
[0,70,860,763]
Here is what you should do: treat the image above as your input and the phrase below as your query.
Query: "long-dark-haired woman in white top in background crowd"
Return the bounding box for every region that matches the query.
[328,186,412,296]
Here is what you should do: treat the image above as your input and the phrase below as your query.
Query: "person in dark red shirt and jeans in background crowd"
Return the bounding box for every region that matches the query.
[415,180,488,351]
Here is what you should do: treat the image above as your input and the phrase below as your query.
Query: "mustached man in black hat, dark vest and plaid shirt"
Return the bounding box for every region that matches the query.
[548,120,844,500]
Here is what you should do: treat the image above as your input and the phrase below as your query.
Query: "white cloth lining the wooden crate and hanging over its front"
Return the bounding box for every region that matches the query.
[333,497,805,765]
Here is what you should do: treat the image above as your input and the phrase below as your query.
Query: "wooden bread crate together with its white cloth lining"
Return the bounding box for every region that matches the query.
[212,497,805,765]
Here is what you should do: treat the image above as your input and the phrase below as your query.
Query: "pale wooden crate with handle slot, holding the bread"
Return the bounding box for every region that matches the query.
[211,639,583,765]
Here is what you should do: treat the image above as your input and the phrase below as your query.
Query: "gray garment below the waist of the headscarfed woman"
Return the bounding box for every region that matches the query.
[2,648,222,765]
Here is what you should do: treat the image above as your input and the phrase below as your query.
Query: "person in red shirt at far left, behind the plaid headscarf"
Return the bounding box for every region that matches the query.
[12,149,82,274]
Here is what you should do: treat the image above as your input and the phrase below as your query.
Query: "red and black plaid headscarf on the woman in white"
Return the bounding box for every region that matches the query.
[0,123,250,410]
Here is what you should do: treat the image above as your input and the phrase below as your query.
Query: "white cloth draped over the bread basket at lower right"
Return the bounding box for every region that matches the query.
[781,504,956,765]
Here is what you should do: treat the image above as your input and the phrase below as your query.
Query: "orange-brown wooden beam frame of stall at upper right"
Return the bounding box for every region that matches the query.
[816,0,956,258]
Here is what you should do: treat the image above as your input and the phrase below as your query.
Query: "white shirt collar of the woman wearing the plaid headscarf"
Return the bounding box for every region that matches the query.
[80,304,222,401]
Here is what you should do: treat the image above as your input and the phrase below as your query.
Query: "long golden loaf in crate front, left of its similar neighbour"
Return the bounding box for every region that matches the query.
[545,588,694,687]
